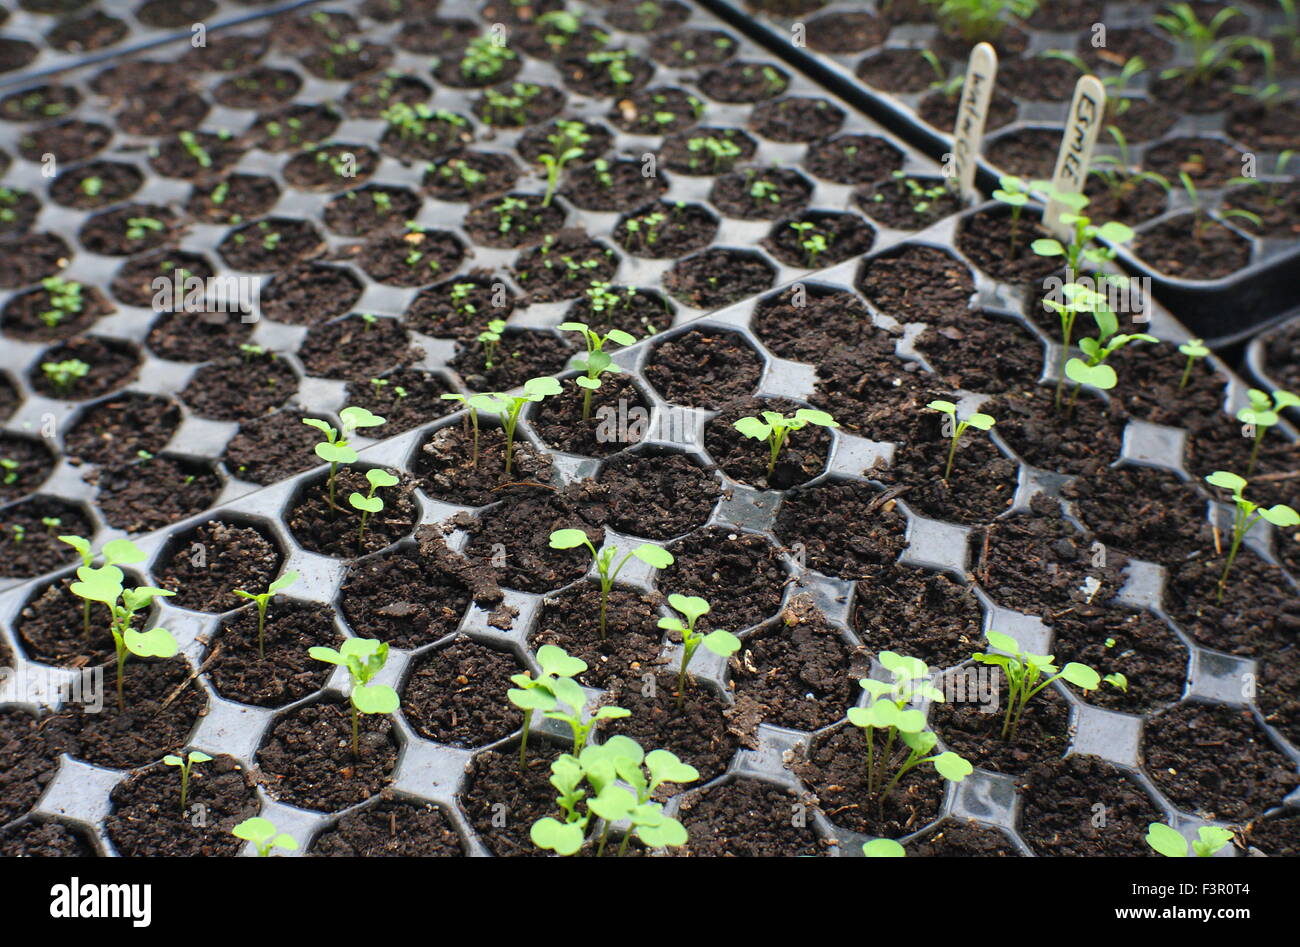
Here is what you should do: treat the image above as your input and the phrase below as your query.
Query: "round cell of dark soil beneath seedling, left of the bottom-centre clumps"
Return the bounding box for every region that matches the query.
[257,700,398,812]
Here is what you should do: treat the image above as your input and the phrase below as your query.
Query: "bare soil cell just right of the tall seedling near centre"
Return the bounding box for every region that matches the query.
[644,328,763,408]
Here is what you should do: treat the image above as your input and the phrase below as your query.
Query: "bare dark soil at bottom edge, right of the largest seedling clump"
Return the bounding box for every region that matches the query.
[675,779,828,859]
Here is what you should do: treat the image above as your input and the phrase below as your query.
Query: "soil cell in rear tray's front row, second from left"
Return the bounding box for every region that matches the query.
[90,457,221,533]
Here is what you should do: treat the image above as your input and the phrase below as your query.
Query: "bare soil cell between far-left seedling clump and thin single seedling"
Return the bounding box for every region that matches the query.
[152,518,285,611]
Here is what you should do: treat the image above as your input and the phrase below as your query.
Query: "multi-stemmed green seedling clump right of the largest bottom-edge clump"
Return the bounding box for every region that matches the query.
[849,650,975,807]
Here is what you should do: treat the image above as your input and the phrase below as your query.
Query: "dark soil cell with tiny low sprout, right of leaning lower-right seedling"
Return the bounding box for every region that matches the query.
[1052,605,1188,714]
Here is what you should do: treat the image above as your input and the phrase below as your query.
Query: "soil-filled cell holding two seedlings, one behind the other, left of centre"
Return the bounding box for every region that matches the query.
[285,464,420,559]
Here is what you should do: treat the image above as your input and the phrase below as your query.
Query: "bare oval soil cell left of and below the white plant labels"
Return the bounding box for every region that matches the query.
[857,247,975,323]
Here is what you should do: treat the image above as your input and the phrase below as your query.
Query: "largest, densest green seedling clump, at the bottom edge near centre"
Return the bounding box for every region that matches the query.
[529,735,699,857]
